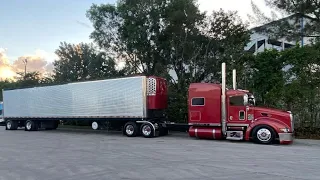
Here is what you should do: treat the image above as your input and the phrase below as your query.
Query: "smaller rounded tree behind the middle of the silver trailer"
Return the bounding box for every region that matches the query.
[54,42,119,82]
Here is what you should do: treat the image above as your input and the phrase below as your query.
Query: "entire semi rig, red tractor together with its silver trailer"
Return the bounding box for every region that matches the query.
[3,63,293,144]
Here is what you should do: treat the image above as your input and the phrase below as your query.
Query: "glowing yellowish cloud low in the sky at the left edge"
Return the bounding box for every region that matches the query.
[0,48,56,80]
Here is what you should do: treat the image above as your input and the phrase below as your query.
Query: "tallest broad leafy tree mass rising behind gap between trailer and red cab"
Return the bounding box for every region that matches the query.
[87,0,249,120]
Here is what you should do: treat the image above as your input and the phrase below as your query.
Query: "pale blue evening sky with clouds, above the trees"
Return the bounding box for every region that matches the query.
[0,0,270,79]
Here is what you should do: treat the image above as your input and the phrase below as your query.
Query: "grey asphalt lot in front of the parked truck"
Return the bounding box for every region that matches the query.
[0,127,320,180]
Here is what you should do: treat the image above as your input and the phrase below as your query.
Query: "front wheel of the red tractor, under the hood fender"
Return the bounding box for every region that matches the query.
[252,125,277,144]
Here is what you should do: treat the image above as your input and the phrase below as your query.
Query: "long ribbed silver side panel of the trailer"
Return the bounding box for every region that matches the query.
[3,76,147,120]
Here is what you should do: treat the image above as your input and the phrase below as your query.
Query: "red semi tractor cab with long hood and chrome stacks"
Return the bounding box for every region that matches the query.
[188,63,294,144]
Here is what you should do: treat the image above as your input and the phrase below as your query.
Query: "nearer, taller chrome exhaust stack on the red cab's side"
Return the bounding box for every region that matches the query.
[221,63,227,137]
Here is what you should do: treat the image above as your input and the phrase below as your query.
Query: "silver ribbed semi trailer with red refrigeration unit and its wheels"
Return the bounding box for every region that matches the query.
[3,76,167,137]
